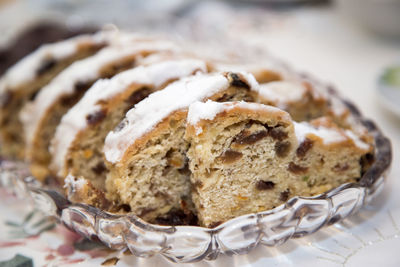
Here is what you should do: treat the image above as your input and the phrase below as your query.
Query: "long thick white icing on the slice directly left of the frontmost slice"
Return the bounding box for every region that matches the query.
[104,73,255,163]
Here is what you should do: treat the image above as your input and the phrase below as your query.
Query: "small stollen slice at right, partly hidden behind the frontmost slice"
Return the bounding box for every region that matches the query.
[287,117,373,196]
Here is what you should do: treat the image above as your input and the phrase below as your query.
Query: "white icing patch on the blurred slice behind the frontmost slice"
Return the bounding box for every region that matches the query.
[258,81,307,109]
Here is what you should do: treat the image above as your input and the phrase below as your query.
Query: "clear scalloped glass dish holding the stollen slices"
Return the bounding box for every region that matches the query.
[0,91,392,262]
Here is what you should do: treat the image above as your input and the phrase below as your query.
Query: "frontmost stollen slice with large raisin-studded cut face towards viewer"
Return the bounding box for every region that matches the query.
[185,101,297,227]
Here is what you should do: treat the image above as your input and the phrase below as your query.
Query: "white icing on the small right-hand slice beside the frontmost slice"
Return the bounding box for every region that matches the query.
[293,122,369,150]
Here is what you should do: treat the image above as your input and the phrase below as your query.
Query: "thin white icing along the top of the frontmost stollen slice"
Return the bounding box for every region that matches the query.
[187,100,290,135]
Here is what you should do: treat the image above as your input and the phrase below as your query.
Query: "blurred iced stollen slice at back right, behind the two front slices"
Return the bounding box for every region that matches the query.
[254,76,373,153]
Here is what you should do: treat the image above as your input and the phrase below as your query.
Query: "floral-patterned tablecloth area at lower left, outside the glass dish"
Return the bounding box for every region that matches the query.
[0,188,120,266]
